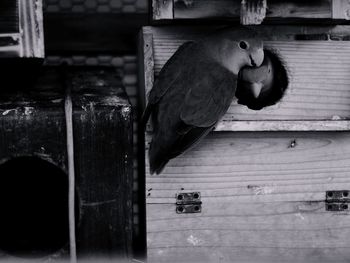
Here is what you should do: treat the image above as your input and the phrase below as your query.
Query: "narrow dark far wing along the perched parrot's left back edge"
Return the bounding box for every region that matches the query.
[142,41,194,128]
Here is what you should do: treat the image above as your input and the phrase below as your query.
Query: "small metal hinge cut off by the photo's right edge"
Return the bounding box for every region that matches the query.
[326,190,350,211]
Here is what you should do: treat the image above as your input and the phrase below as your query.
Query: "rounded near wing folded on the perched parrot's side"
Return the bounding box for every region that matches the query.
[180,62,237,127]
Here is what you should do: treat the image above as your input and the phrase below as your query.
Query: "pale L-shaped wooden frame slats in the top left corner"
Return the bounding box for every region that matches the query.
[0,0,44,58]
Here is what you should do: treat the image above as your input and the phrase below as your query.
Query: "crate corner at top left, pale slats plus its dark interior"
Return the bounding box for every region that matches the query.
[0,0,44,58]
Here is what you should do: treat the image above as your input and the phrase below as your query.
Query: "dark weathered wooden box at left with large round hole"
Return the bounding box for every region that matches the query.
[0,68,133,261]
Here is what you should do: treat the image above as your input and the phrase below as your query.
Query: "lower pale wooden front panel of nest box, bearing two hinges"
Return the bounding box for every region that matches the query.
[146,132,350,262]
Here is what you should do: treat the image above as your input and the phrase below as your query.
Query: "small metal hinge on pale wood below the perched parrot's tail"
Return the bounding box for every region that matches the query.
[176,192,202,214]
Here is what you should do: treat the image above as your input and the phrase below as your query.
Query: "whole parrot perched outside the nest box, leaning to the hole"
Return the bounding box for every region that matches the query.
[142,29,264,174]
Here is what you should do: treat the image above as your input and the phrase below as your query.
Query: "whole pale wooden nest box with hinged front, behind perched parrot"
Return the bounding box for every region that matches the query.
[140,26,350,262]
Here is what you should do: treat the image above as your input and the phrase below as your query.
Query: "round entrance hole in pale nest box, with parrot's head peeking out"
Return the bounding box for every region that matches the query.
[236,49,289,110]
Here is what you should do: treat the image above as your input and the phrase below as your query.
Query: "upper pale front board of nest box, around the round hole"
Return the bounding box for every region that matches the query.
[141,26,350,126]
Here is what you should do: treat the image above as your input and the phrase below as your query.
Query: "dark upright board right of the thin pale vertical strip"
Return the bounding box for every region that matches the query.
[69,68,133,259]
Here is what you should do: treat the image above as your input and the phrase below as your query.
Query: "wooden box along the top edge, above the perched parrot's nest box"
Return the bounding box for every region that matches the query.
[151,0,350,22]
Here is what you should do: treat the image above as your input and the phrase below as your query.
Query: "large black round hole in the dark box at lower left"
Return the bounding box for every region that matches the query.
[0,157,69,257]
